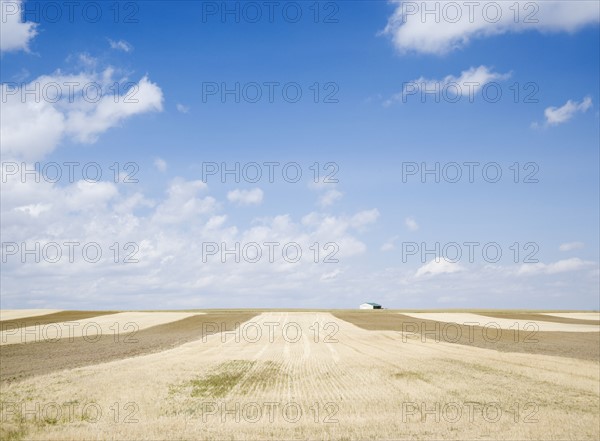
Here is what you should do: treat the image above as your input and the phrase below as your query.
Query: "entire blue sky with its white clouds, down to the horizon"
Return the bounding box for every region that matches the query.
[0,1,600,309]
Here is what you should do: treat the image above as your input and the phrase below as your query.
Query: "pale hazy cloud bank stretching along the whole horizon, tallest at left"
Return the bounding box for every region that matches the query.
[0,169,598,309]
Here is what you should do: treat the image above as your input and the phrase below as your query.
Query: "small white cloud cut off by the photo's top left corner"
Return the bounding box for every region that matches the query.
[0,0,37,52]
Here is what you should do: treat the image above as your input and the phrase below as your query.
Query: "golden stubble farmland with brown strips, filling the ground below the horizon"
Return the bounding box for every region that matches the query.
[0,311,600,440]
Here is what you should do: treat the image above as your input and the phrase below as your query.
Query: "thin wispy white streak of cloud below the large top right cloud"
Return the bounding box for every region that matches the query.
[383,65,511,106]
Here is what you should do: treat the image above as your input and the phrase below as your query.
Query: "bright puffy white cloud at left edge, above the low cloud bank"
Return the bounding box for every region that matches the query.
[0,69,163,161]
